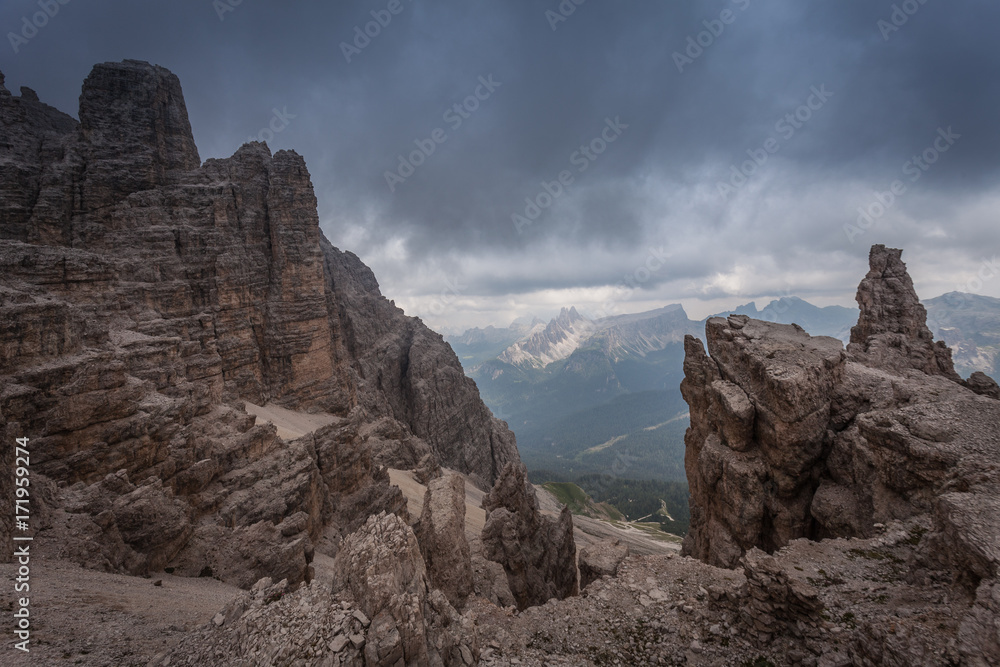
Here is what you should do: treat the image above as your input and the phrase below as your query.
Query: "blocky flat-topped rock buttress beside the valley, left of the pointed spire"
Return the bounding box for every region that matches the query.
[681,315,845,567]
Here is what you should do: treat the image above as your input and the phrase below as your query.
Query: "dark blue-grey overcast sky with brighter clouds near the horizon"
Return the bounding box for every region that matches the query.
[0,0,1000,331]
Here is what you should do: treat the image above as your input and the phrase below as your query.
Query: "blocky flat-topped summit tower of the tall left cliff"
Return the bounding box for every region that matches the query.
[80,60,201,172]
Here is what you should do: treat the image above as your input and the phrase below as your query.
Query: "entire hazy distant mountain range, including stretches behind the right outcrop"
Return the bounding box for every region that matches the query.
[448,293,1000,490]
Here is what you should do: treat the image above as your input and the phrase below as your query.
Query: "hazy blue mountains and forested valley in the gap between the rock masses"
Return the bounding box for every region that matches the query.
[449,304,702,480]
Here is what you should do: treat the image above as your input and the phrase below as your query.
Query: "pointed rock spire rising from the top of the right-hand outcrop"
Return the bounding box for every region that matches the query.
[847,245,961,381]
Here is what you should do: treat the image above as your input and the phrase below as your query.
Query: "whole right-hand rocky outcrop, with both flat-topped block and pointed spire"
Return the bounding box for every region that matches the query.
[681,246,1000,567]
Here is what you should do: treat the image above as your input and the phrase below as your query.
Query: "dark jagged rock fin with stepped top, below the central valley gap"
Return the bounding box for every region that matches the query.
[482,463,580,609]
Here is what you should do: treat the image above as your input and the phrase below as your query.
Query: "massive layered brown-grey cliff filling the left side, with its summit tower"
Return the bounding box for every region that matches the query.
[0,61,519,587]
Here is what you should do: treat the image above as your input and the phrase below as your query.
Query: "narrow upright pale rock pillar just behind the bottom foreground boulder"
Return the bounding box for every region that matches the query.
[414,475,473,609]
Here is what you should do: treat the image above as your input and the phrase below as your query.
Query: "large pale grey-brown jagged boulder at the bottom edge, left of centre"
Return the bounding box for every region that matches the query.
[334,513,478,667]
